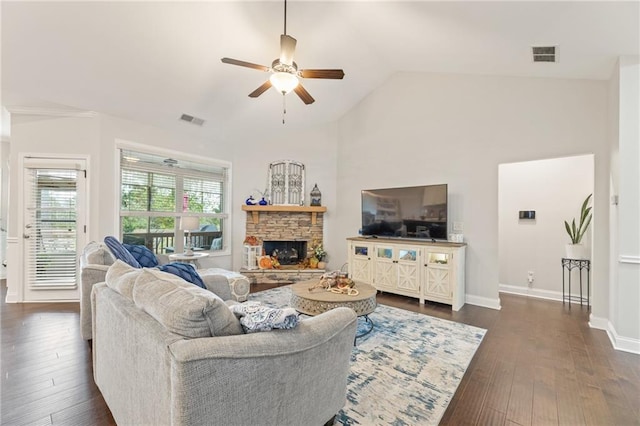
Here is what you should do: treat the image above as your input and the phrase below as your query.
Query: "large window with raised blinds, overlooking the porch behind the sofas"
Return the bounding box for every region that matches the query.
[120,149,230,253]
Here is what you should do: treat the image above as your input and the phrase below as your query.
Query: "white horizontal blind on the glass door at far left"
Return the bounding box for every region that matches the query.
[25,169,79,288]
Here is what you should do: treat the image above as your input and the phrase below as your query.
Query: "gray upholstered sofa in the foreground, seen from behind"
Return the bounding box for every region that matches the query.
[91,261,356,426]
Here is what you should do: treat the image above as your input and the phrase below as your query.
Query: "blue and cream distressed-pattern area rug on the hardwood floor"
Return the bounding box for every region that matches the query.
[249,287,486,426]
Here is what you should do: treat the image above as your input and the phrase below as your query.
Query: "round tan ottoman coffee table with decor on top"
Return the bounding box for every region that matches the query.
[290,280,377,338]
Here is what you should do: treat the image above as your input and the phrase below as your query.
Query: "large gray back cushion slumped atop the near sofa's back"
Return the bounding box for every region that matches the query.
[133,269,242,338]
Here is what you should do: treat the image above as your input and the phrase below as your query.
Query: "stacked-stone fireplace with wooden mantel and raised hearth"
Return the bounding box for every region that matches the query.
[240,205,326,284]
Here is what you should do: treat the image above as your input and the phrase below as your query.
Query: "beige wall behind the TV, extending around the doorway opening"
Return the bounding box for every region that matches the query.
[337,73,608,315]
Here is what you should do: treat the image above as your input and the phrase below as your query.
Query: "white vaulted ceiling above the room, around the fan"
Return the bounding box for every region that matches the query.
[0,0,640,139]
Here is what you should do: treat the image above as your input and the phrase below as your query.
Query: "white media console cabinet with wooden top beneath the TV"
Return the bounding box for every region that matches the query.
[347,237,466,311]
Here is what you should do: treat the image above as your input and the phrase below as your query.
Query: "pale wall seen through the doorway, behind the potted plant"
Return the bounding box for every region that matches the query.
[498,154,595,301]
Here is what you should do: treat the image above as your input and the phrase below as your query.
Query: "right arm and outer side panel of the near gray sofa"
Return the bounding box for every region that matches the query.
[169,308,357,425]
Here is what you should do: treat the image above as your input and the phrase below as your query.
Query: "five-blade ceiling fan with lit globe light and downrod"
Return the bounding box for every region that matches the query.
[222,0,344,105]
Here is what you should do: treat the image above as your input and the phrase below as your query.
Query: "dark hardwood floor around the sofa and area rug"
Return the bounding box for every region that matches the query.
[0,282,640,426]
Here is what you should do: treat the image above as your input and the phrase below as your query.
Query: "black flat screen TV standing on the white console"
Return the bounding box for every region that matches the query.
[362,184,447,240]
